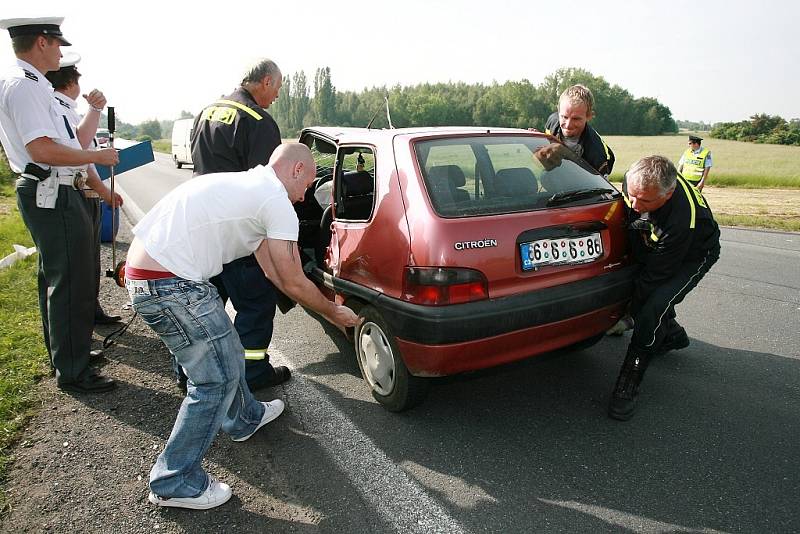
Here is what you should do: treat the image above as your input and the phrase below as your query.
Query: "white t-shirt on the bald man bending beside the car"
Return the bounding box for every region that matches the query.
[133,165,299,281]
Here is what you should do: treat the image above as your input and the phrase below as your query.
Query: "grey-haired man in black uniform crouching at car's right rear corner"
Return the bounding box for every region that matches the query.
[608,156,720,421]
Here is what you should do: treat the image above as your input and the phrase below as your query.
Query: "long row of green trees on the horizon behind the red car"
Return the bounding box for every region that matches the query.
[269,67,678,137]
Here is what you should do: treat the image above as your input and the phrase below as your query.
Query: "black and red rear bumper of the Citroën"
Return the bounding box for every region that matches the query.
[310,265,637,375]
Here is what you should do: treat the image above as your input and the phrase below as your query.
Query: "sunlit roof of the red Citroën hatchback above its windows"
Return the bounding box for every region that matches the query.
[301,126,543,144]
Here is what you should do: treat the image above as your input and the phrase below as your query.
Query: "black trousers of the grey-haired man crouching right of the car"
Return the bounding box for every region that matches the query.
[631,248,719,354]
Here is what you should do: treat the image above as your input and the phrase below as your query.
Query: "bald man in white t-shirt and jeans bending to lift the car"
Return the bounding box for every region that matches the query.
[125,143,358,509]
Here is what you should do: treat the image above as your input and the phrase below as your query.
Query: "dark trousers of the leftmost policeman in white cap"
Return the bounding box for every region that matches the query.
[16,178,95,384]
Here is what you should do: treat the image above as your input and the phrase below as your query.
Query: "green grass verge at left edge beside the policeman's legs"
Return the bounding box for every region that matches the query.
[0,154,47,509]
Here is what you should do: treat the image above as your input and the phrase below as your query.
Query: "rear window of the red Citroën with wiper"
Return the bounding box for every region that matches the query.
[414,136,619,217]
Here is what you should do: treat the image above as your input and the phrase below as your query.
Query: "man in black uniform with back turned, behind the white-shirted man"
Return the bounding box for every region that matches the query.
[191,59,291,391]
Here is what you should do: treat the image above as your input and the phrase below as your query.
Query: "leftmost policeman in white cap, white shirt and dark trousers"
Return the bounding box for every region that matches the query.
[0,17,119,393]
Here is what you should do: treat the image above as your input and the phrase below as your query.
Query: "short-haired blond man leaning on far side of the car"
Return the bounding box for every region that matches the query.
[545,85,615,176]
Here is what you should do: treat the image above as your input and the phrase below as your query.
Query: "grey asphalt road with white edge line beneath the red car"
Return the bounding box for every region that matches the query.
[118,155,800,533]
